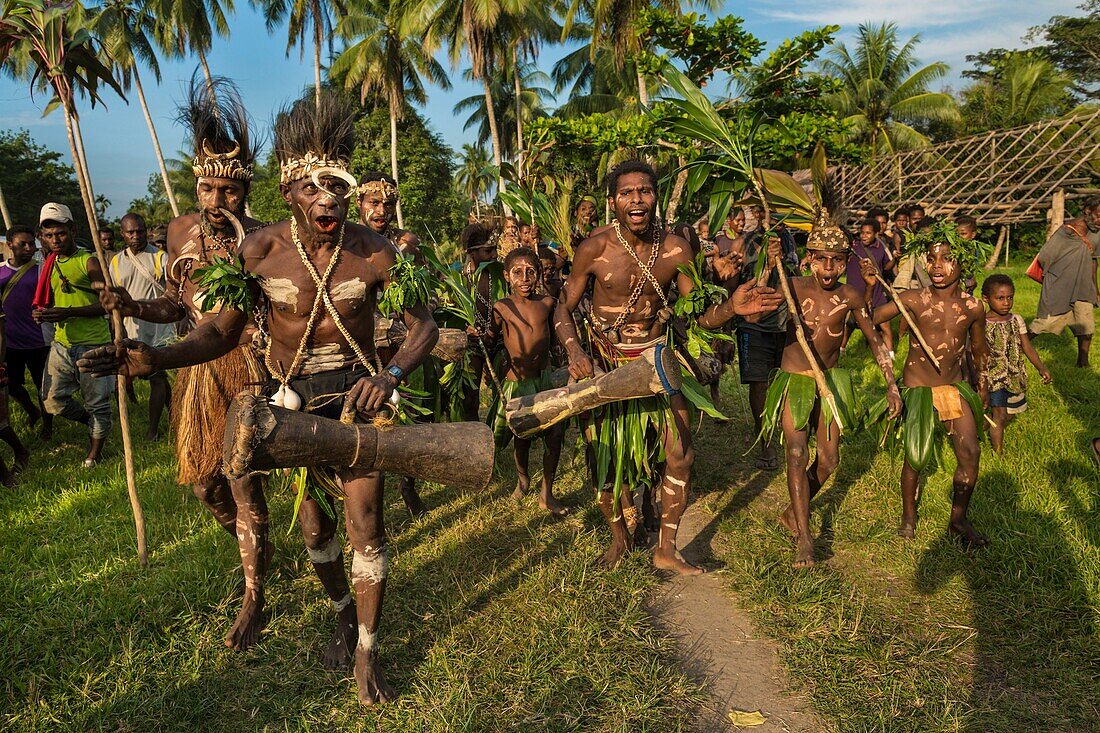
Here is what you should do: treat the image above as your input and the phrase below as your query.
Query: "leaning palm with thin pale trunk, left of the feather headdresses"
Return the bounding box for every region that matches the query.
[95,0,179,217]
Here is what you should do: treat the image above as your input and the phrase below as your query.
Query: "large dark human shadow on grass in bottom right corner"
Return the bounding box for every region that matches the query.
[914,470,1100,733]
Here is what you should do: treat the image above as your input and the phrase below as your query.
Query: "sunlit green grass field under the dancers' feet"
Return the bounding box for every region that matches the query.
[0,270,1100,732]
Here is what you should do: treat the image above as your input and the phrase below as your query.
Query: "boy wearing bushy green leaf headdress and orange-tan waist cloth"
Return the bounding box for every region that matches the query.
[875,221,989,547]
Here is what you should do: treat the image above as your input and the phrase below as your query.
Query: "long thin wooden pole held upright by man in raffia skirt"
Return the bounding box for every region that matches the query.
[65,103,149,568]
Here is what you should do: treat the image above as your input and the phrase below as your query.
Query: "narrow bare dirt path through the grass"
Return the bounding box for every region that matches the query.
[648,502,829,733]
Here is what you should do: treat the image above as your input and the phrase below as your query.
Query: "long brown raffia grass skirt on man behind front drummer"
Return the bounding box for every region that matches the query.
[172,344,263,484]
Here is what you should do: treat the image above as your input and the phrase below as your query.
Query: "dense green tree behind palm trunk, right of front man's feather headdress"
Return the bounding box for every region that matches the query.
[351,106,465,241]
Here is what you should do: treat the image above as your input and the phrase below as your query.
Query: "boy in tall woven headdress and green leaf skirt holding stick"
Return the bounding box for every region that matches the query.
[760,209,901,568]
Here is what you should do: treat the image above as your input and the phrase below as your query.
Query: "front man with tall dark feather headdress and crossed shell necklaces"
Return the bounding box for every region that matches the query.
[85,92,439,704]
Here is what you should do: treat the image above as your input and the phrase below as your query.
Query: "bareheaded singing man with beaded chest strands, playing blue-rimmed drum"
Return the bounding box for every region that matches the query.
[554,161,780,575]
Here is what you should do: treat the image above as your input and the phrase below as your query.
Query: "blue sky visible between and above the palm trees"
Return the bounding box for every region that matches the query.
[0,0,1080,216]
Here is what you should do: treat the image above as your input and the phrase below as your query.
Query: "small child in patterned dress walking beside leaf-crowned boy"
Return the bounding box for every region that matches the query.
[981,274,1051,453]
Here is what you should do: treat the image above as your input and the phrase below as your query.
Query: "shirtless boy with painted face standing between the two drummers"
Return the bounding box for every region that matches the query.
[487,247,569,516]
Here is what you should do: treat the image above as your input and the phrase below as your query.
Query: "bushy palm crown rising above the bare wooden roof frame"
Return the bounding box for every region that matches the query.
[821,23,959,153]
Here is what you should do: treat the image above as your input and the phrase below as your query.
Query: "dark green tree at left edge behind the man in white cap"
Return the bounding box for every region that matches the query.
[0,130,90,238]
